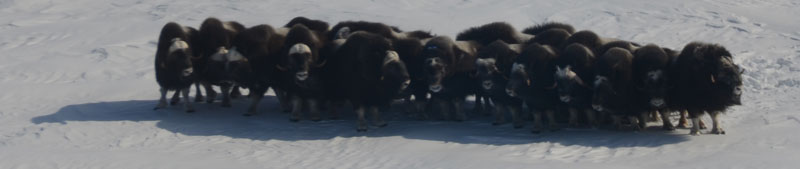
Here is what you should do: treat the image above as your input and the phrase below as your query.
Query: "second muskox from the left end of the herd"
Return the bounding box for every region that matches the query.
[195,18,245,107]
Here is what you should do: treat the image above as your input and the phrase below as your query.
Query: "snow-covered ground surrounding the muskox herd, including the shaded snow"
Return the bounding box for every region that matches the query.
[0,0,800,169]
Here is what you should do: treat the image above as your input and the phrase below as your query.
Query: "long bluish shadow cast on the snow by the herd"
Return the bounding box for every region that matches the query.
[31,96,689,148]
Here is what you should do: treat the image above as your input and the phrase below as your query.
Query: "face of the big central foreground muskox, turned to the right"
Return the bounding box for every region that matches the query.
[381,51,411,94]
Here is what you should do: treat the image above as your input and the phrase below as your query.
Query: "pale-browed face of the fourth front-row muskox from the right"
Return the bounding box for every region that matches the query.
[555,65,586,103]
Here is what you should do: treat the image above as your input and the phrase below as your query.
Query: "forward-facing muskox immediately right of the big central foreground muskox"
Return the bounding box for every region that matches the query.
[422,36,480,121]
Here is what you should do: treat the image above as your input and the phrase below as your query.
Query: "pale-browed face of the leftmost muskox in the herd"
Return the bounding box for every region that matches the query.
[161,38,194,79]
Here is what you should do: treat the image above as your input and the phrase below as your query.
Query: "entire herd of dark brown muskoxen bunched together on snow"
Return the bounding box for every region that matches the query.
[155,17,743,135]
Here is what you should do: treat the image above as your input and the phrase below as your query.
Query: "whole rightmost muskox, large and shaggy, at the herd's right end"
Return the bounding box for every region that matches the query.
[669,42,744,135]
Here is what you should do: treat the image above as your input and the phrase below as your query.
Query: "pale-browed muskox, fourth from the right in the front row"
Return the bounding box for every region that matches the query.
[555,43,598,127]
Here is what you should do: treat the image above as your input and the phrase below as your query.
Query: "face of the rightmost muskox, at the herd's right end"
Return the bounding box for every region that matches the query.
[711,56,744,105]
